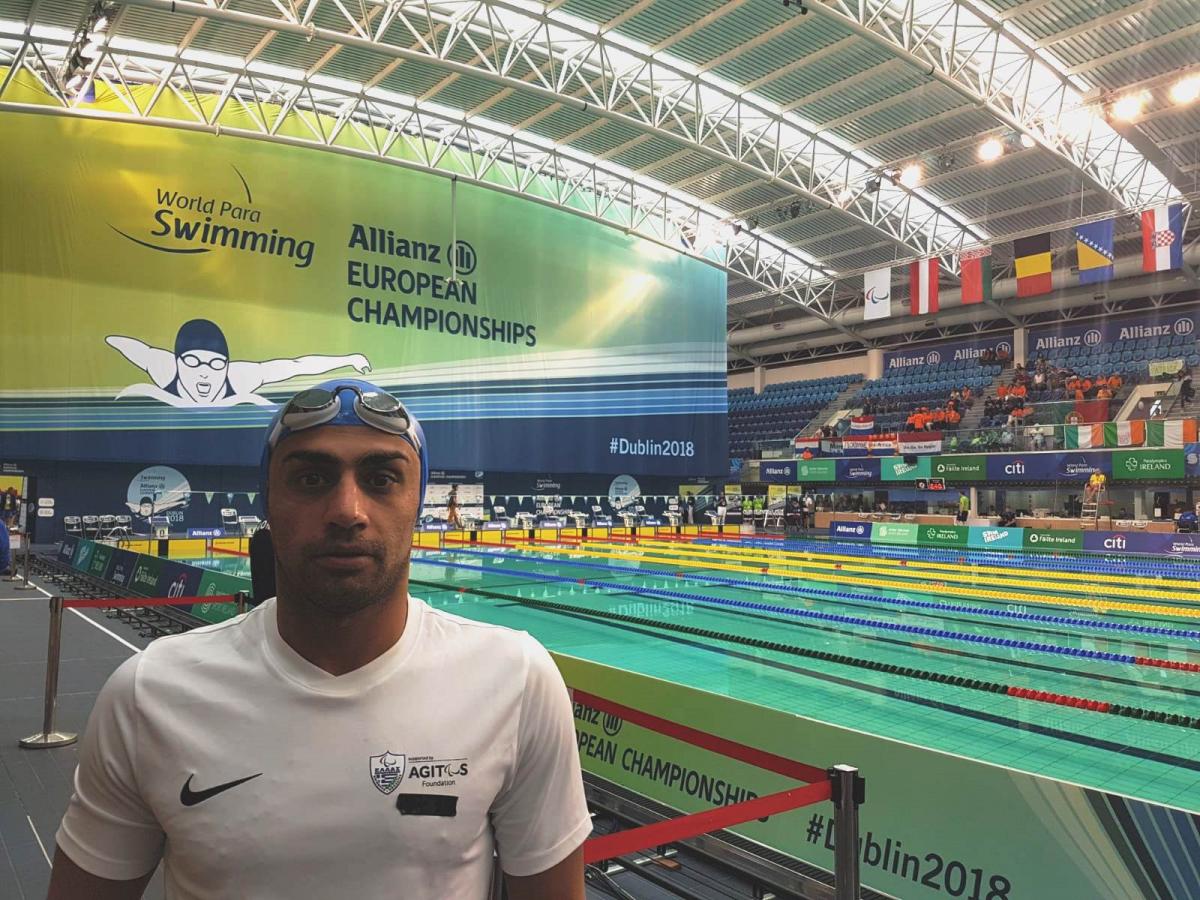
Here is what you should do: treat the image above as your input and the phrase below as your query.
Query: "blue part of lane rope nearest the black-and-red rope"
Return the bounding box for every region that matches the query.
[413,559,1138,665]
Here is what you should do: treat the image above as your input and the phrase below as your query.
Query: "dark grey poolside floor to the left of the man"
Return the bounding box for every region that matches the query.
[0,578,163,900]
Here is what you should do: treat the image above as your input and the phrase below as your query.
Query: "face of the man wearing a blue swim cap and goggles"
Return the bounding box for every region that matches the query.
[268,426,421,616]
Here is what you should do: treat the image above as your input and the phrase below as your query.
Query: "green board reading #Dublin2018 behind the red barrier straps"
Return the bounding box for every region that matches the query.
[553,653,1200,900]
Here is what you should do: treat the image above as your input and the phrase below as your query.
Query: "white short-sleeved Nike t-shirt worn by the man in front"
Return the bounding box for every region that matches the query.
[58,598,592,900]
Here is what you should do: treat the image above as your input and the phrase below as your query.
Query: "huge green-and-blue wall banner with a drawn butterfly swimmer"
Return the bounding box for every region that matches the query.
[0,103,727,475]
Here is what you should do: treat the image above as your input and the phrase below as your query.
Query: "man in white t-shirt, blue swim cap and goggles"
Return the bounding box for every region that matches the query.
[49,379,592,900]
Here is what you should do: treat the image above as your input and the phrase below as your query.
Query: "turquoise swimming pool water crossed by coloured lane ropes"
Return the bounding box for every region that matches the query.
[182,540,1200,811]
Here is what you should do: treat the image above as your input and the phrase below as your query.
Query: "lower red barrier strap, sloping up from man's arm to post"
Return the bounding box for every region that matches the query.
[583,773,833,863]
